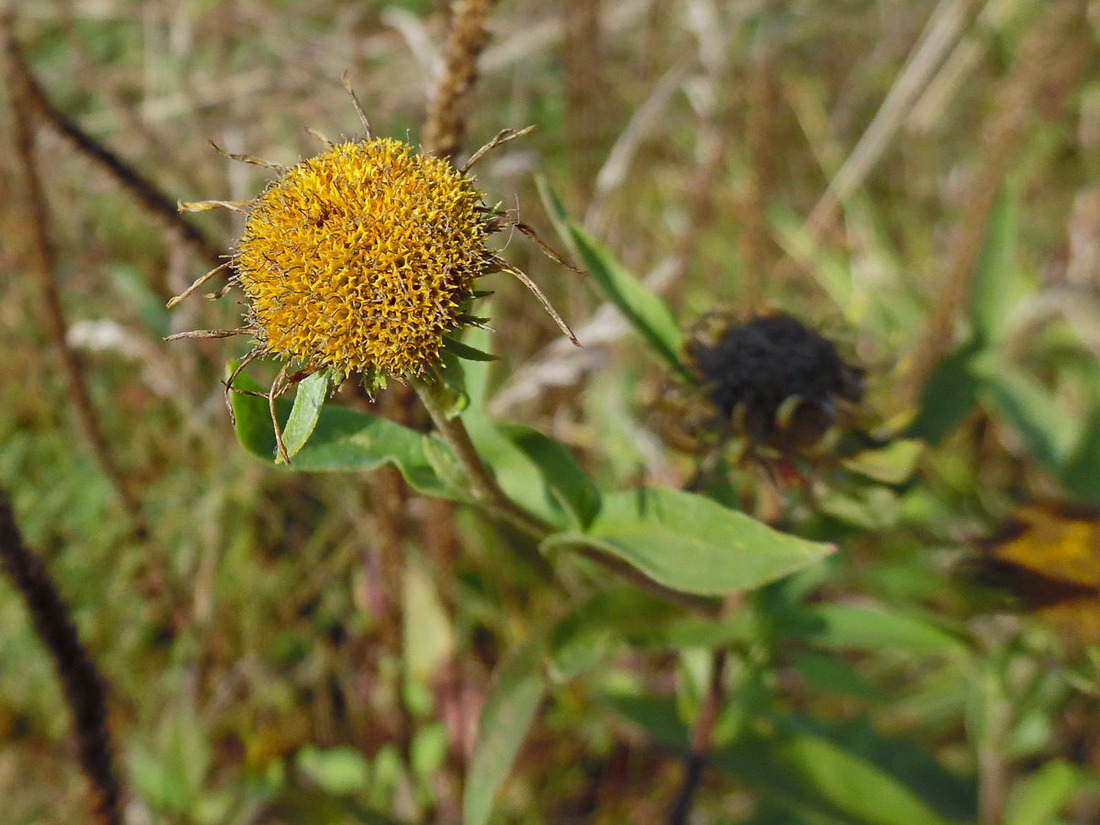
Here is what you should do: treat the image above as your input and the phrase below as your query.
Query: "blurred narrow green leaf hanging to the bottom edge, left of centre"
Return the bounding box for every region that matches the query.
[462,644,546,825]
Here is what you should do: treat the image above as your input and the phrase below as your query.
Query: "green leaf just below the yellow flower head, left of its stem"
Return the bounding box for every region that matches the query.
[230,375,459,502]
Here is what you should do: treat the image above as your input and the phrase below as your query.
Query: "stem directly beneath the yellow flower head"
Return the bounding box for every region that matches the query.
[409,375,554,539]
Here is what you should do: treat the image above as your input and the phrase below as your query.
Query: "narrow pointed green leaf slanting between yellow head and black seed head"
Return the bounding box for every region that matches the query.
[539,179,690,377]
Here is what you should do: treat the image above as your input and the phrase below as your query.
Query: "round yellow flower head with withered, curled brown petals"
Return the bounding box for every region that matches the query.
[168,78,578,461]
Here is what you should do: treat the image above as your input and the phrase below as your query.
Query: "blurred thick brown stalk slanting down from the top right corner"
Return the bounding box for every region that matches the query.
[902,0,1092,408]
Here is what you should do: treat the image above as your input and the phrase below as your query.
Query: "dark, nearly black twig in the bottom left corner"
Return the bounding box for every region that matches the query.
[0,492,122,825]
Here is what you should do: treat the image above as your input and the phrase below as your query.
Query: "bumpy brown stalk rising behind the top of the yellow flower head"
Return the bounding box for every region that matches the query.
[424,0,495,161]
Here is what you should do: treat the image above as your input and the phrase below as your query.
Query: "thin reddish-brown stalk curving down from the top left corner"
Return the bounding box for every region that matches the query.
[0,18,147,537]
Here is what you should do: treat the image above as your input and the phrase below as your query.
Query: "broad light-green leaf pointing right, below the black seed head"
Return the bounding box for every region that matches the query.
[542,490,835,596]
